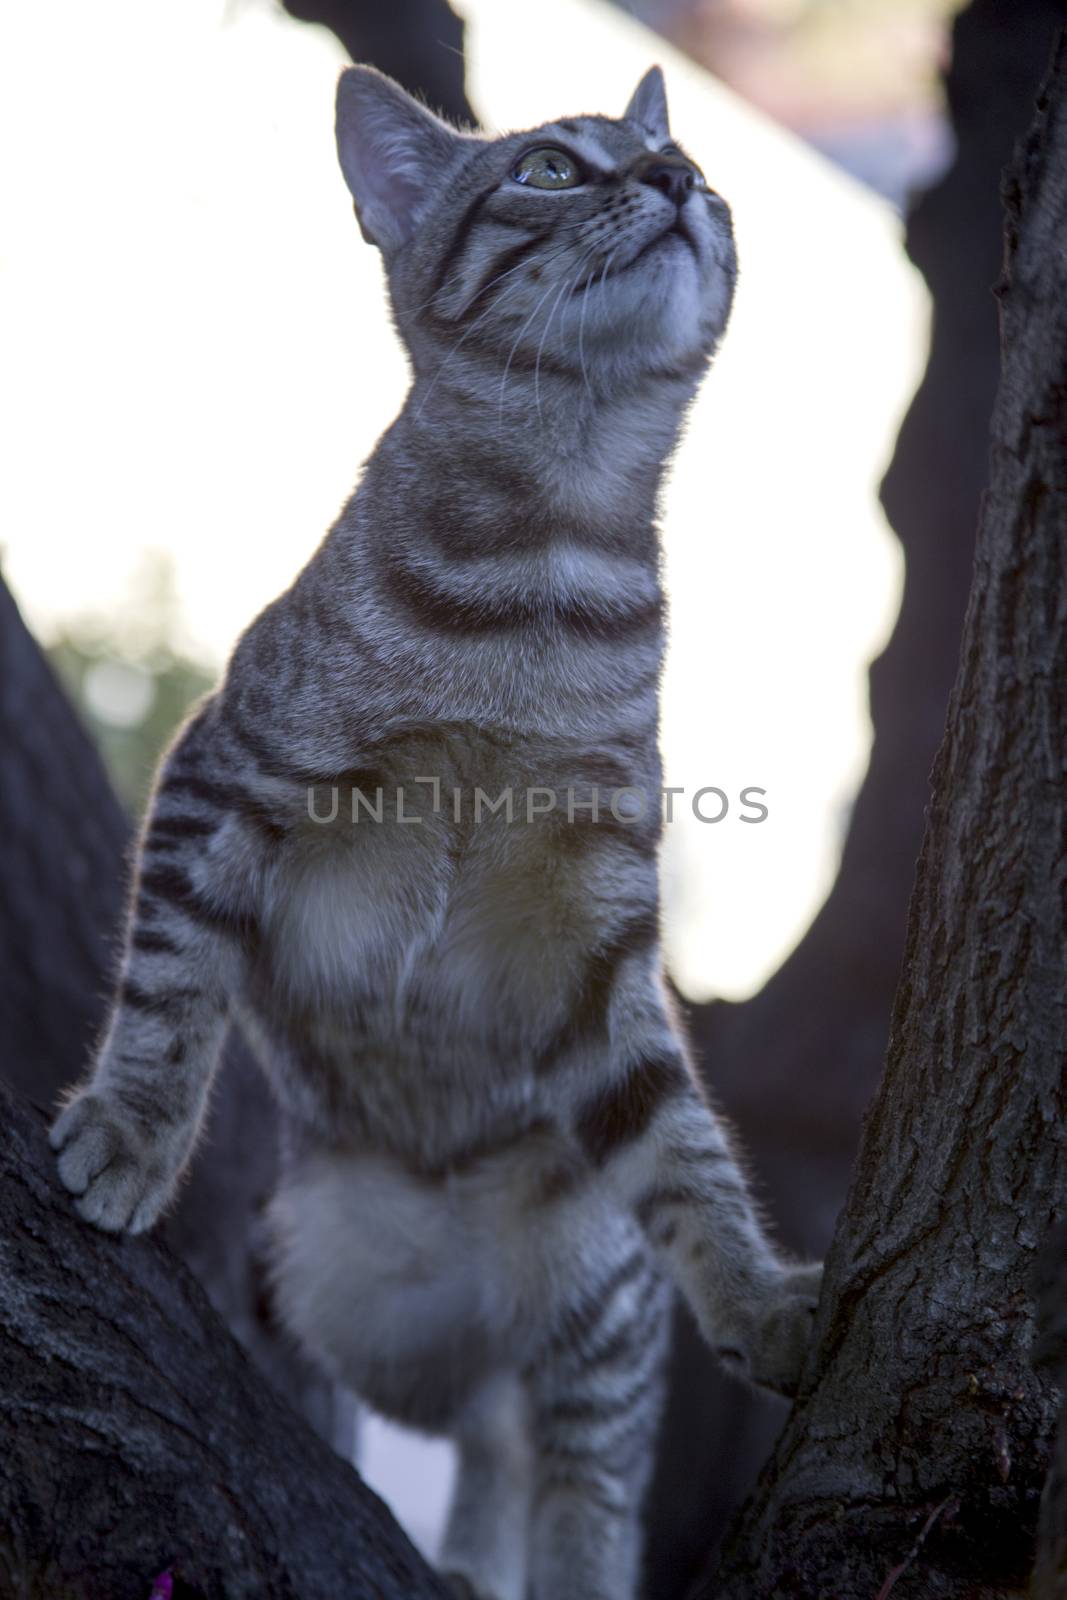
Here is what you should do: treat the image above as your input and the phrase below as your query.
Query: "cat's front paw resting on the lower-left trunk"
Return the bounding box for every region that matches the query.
[48,1090,179,1234]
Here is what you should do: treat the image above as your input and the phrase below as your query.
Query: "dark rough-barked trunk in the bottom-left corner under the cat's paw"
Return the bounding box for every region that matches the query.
[0,1088,445,1600]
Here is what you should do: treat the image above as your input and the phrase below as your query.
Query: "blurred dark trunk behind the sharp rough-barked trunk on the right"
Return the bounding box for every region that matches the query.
[649,9,1067,1600]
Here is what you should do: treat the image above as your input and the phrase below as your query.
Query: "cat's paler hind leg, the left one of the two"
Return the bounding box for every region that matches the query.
[438,1373,531,1600]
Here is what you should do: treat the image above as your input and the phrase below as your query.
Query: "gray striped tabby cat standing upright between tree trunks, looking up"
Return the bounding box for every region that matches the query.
[53,67,819,1600]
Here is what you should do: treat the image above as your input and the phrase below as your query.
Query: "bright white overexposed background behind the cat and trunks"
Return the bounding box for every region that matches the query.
[0,0,926,1544]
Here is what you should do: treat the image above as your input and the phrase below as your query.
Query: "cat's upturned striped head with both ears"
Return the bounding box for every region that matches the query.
[338,67,736,396]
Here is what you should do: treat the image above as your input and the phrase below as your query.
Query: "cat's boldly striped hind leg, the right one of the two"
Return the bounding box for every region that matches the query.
[526,1229,670,1600]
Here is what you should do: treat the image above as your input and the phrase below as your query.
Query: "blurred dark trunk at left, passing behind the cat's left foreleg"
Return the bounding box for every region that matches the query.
[0,581,340,1443]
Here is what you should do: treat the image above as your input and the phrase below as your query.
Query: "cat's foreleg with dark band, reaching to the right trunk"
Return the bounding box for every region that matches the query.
[576,981,822,1394]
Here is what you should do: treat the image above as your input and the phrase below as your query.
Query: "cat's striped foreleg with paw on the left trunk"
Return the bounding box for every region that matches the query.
[51,716,251,1234]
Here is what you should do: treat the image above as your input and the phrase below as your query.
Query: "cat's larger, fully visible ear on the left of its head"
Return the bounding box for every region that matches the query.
[338,67,459,258]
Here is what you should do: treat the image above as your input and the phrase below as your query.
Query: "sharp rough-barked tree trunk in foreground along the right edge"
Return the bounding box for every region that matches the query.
[707,43,1067,1600]
